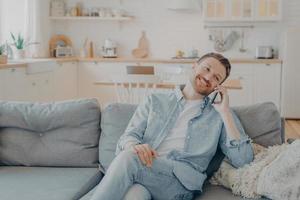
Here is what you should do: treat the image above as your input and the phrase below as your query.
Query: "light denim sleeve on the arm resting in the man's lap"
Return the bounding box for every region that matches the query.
[116,96,151,155]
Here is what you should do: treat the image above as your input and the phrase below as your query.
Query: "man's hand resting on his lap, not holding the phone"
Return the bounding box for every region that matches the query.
[132,144,158,167]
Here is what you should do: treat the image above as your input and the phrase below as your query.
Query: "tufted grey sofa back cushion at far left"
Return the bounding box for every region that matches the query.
[0,99,100,167]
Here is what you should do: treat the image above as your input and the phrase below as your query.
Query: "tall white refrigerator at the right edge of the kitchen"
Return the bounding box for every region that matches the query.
[281,27,300,119]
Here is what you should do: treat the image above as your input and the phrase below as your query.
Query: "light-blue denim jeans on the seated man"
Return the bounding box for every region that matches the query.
[91,151,193,200]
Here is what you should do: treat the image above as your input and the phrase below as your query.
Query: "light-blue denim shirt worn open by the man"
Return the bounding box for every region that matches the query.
[116,88,253,191]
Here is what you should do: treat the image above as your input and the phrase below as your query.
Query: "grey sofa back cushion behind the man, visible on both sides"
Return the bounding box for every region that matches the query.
[99,103,284,170]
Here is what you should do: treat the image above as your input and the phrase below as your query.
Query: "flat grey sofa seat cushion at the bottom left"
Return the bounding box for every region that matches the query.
[0,166,98,200]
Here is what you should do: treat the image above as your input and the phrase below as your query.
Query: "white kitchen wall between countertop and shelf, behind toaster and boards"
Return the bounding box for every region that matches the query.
[50,0,285,58]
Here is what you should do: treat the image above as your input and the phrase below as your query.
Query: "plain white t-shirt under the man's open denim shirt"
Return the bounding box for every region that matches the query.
[156,100,202,156]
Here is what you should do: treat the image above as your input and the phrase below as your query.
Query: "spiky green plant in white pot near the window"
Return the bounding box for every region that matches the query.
[10,33,38,59]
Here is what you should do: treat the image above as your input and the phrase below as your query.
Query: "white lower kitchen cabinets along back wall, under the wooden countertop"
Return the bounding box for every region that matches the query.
[78,62,281,109]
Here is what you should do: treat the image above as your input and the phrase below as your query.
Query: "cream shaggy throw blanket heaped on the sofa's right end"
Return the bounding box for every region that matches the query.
[210,140,300,200]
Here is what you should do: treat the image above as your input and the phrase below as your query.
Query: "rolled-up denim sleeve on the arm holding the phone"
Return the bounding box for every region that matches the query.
[219,111,253,168]
